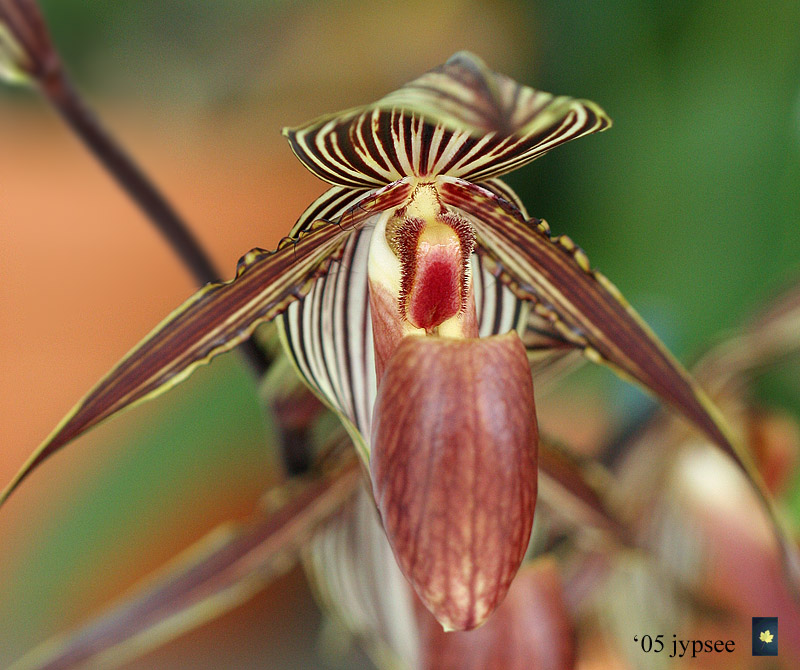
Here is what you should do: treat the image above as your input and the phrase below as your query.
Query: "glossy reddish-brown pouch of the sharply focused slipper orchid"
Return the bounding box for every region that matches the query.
[370,332,537,630]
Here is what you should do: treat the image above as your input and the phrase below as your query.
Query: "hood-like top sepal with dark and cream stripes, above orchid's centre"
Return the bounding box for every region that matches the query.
[283,52,611,188]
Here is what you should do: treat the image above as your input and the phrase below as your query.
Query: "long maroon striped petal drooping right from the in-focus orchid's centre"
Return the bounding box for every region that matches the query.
[440,178,800,594]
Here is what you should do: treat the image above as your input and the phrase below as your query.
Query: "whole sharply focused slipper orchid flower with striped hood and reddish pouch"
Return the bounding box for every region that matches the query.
[0,53,788,630]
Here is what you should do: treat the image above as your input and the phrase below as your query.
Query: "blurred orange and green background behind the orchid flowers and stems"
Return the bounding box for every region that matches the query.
[0,0,800,668]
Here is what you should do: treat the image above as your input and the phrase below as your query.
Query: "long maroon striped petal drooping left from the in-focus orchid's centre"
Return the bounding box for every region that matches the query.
[0,182,408,504]
